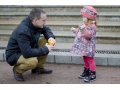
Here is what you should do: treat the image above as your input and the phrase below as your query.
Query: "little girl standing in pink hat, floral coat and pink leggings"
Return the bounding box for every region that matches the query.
[71,6,97,82]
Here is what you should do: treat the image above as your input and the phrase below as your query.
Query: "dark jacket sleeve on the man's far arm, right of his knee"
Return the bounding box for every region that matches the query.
[42,26,55,40]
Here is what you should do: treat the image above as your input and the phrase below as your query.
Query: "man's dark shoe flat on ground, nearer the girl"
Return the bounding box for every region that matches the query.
[32,68,52,74]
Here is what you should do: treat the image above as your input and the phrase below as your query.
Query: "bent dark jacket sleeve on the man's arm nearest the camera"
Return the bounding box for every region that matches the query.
[17,30,49,58]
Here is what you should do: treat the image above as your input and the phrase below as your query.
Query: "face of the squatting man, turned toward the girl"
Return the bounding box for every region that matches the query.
[33,14,47,28]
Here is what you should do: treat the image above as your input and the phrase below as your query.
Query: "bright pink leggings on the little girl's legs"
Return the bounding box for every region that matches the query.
[83,56,96,71]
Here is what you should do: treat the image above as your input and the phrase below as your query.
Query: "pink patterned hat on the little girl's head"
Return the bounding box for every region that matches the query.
[80,6,97,20]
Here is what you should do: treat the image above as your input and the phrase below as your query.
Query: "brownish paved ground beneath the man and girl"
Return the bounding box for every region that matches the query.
[0,62,120,84]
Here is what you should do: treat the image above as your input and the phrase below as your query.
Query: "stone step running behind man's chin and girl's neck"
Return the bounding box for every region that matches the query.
[0,20,120,32]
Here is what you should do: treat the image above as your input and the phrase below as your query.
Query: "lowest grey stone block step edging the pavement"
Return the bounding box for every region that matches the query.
[0,50,120,66]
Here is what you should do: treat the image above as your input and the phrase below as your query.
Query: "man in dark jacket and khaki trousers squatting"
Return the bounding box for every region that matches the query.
[6,8,56,81]
